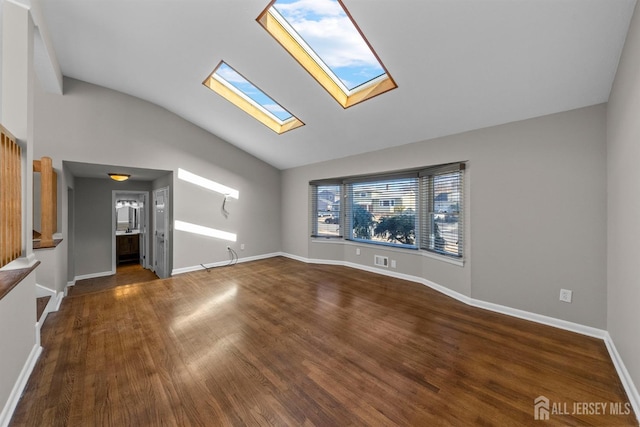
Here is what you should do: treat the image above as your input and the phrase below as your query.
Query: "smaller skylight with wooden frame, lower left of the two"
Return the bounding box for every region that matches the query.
[203,61,304,134]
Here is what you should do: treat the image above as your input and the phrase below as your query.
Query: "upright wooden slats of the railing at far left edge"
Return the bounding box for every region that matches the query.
[0,126,22,267]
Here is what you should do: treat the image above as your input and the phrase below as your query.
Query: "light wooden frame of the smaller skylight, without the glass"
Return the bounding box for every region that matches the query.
[202,60,304,135]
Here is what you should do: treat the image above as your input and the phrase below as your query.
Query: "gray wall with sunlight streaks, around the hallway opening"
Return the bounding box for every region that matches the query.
[35,79,281,275]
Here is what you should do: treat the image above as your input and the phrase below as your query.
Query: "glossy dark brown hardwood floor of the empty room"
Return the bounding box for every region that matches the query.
[11,258,636,426]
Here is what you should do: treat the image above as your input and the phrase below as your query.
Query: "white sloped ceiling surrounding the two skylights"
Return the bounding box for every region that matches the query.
[42,0,635,169]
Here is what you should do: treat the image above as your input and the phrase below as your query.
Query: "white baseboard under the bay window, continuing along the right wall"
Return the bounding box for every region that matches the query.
[279,253,640,423]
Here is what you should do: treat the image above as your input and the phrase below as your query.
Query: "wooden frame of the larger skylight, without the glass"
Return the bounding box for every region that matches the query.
[256,0,398,108]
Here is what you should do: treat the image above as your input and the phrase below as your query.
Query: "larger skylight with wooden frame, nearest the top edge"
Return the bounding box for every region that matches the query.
[258,0,397,108]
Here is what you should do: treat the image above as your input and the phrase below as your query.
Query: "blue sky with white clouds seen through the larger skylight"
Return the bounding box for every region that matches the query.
[273,0,384,90]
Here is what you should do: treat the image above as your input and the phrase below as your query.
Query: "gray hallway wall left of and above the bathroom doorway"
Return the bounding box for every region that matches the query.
[74,178,151,276]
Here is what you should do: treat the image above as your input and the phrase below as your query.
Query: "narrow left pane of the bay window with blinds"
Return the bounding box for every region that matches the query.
[311,184,342,237]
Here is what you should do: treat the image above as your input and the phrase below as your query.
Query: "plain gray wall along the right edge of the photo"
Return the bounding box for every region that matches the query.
[607,0,640,402]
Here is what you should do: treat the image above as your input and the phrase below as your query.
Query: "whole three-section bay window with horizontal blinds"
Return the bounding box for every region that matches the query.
[309,163,465,258]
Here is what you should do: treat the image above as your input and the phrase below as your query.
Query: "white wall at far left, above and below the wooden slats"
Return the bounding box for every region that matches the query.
[0,3,40,425]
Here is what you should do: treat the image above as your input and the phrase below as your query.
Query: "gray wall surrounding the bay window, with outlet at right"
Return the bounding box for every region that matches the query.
[282,105,607,329]
